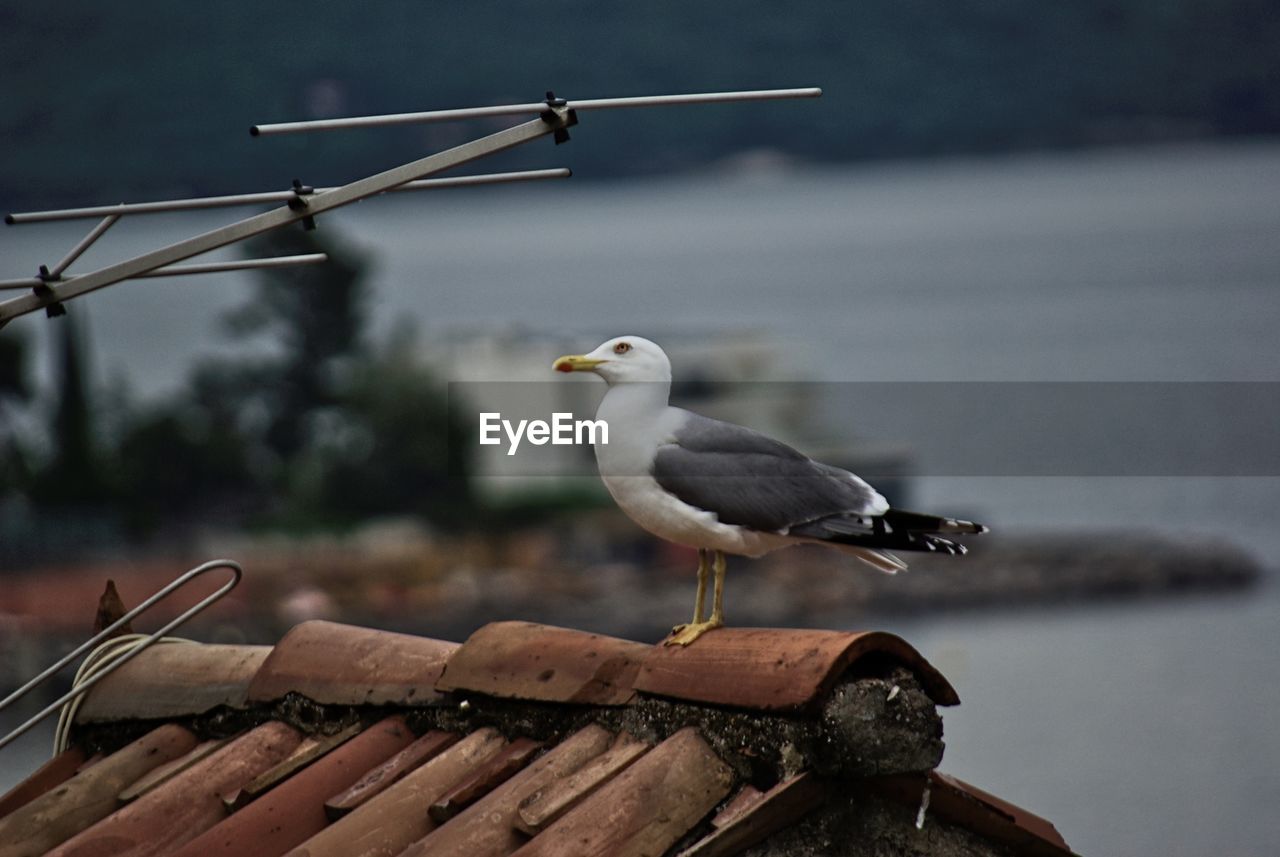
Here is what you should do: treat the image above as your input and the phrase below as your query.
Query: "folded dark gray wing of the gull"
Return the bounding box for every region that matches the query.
[653,413,884,532]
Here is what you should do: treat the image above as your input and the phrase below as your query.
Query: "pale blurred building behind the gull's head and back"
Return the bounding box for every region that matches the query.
[414,326,908,499]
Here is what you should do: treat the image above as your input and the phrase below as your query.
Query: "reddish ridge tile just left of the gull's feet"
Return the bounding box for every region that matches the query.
[436,622,649,705]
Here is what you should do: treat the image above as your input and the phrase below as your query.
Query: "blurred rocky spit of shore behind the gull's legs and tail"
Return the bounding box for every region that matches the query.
[345,536,1266,642]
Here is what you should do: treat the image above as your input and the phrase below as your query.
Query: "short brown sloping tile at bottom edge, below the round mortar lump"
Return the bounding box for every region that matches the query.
[680,773,827,857]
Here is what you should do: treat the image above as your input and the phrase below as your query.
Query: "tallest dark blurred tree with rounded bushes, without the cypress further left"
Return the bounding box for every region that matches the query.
[118,221,471,532]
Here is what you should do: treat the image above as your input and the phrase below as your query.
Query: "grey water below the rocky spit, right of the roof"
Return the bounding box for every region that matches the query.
[887,586,1280,857]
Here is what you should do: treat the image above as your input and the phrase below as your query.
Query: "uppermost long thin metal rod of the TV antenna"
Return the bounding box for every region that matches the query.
[248,87,822,137]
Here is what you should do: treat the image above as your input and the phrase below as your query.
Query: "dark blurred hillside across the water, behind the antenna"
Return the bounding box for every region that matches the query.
[0,0,1280,210]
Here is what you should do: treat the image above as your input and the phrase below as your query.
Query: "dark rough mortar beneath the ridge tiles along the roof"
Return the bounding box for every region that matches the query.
[77,668,943,787]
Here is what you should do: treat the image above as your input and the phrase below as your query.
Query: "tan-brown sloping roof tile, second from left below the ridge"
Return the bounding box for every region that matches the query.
[0,723,196,857]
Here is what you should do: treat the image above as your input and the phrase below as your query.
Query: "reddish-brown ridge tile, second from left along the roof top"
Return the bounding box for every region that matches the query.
[248,620,458,705]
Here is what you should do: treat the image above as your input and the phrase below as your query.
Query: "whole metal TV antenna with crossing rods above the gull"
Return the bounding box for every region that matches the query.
[0,88,822,327]
